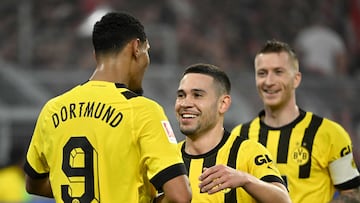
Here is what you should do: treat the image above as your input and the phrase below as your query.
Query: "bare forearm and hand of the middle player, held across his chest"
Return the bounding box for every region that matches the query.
[199,165,291,203]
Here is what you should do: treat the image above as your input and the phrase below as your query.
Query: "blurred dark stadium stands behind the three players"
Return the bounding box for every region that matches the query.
[0,0,360,170]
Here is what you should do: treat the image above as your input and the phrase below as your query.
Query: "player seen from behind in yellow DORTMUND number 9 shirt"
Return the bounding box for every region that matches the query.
[24,12,191,203]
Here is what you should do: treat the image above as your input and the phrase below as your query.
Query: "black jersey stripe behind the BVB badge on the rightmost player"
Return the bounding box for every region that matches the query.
[299,115,323,178]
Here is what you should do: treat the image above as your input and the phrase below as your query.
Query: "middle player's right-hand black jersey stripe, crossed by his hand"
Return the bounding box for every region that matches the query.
[224,135,249,203]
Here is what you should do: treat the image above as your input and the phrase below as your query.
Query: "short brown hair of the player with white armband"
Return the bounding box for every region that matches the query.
[256,39,299,70]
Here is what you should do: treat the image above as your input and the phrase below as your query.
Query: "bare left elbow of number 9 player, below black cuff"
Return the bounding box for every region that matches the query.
[25,175,54,198]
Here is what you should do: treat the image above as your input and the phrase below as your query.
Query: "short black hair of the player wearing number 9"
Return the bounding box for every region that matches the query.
[92,12,147,54]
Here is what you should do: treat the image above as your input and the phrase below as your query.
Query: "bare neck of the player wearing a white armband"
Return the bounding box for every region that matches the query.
[262,105,300,127]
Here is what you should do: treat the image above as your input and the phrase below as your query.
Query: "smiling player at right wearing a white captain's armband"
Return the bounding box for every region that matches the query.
[232,40,360,203]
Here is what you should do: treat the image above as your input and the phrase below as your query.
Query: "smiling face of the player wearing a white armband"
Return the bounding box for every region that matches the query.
[255,52,301,110]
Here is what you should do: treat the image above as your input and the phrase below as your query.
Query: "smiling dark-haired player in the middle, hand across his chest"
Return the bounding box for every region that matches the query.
[175,64,290,203]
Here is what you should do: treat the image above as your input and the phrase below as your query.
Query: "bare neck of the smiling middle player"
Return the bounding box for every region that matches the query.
[185,126,224,155]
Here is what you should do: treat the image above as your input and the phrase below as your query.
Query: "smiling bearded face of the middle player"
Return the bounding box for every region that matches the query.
[175,73,226,136]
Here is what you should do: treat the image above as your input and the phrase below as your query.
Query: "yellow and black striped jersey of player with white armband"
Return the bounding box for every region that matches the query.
[232,110,360,203]
